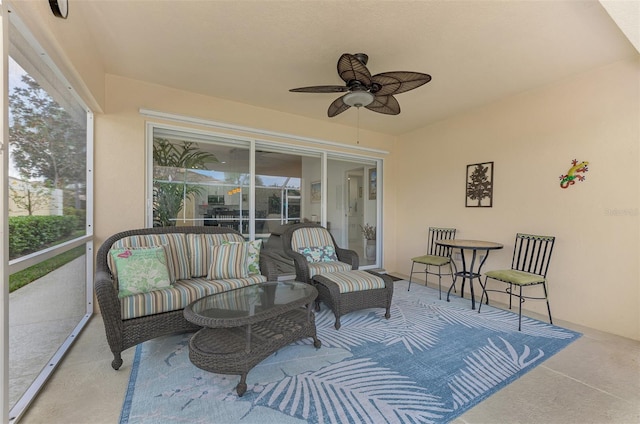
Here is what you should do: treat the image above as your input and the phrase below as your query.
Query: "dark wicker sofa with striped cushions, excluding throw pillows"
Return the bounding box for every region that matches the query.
[95,227,277,370]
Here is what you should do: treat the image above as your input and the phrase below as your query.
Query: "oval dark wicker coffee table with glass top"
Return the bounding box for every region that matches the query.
[184,282,321,396]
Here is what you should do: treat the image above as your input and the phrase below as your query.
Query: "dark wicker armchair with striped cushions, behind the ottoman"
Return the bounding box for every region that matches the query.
[282,223,360,284]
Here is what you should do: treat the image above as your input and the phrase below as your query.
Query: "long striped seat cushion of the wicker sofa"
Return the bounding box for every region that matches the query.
[120,275,267,319]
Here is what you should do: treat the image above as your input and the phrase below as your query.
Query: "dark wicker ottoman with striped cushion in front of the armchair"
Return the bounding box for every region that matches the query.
[312,270,393,330]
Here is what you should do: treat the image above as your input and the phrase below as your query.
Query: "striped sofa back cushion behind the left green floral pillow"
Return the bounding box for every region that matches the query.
[107,233,191,280]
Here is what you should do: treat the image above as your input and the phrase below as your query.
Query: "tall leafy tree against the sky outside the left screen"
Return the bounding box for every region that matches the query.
[9,74,87,230]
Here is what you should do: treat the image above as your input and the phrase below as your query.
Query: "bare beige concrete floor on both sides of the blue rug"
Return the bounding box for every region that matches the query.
[12,278,640,424]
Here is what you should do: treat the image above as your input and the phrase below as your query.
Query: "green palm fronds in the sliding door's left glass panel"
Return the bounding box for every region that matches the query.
[153,138,218,227]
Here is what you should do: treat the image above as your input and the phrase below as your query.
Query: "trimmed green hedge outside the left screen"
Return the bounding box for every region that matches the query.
[9,215,78,259]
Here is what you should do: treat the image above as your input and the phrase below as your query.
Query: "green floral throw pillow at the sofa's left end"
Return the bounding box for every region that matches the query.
[109,246,171,298]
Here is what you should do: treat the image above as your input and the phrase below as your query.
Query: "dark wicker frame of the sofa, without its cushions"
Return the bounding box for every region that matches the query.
[95,227,277,370]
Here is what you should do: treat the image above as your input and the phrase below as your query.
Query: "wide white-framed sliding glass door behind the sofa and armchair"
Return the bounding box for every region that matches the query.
[148,124,381,274]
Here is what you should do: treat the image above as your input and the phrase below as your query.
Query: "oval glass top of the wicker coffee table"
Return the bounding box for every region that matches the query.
[184,281,318,328]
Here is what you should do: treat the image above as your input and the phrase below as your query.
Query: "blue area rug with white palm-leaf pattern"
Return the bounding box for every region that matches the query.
[120,281,580,424]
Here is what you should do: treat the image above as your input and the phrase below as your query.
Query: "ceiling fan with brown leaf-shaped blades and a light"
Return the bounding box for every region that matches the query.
[289,53,431,118]
